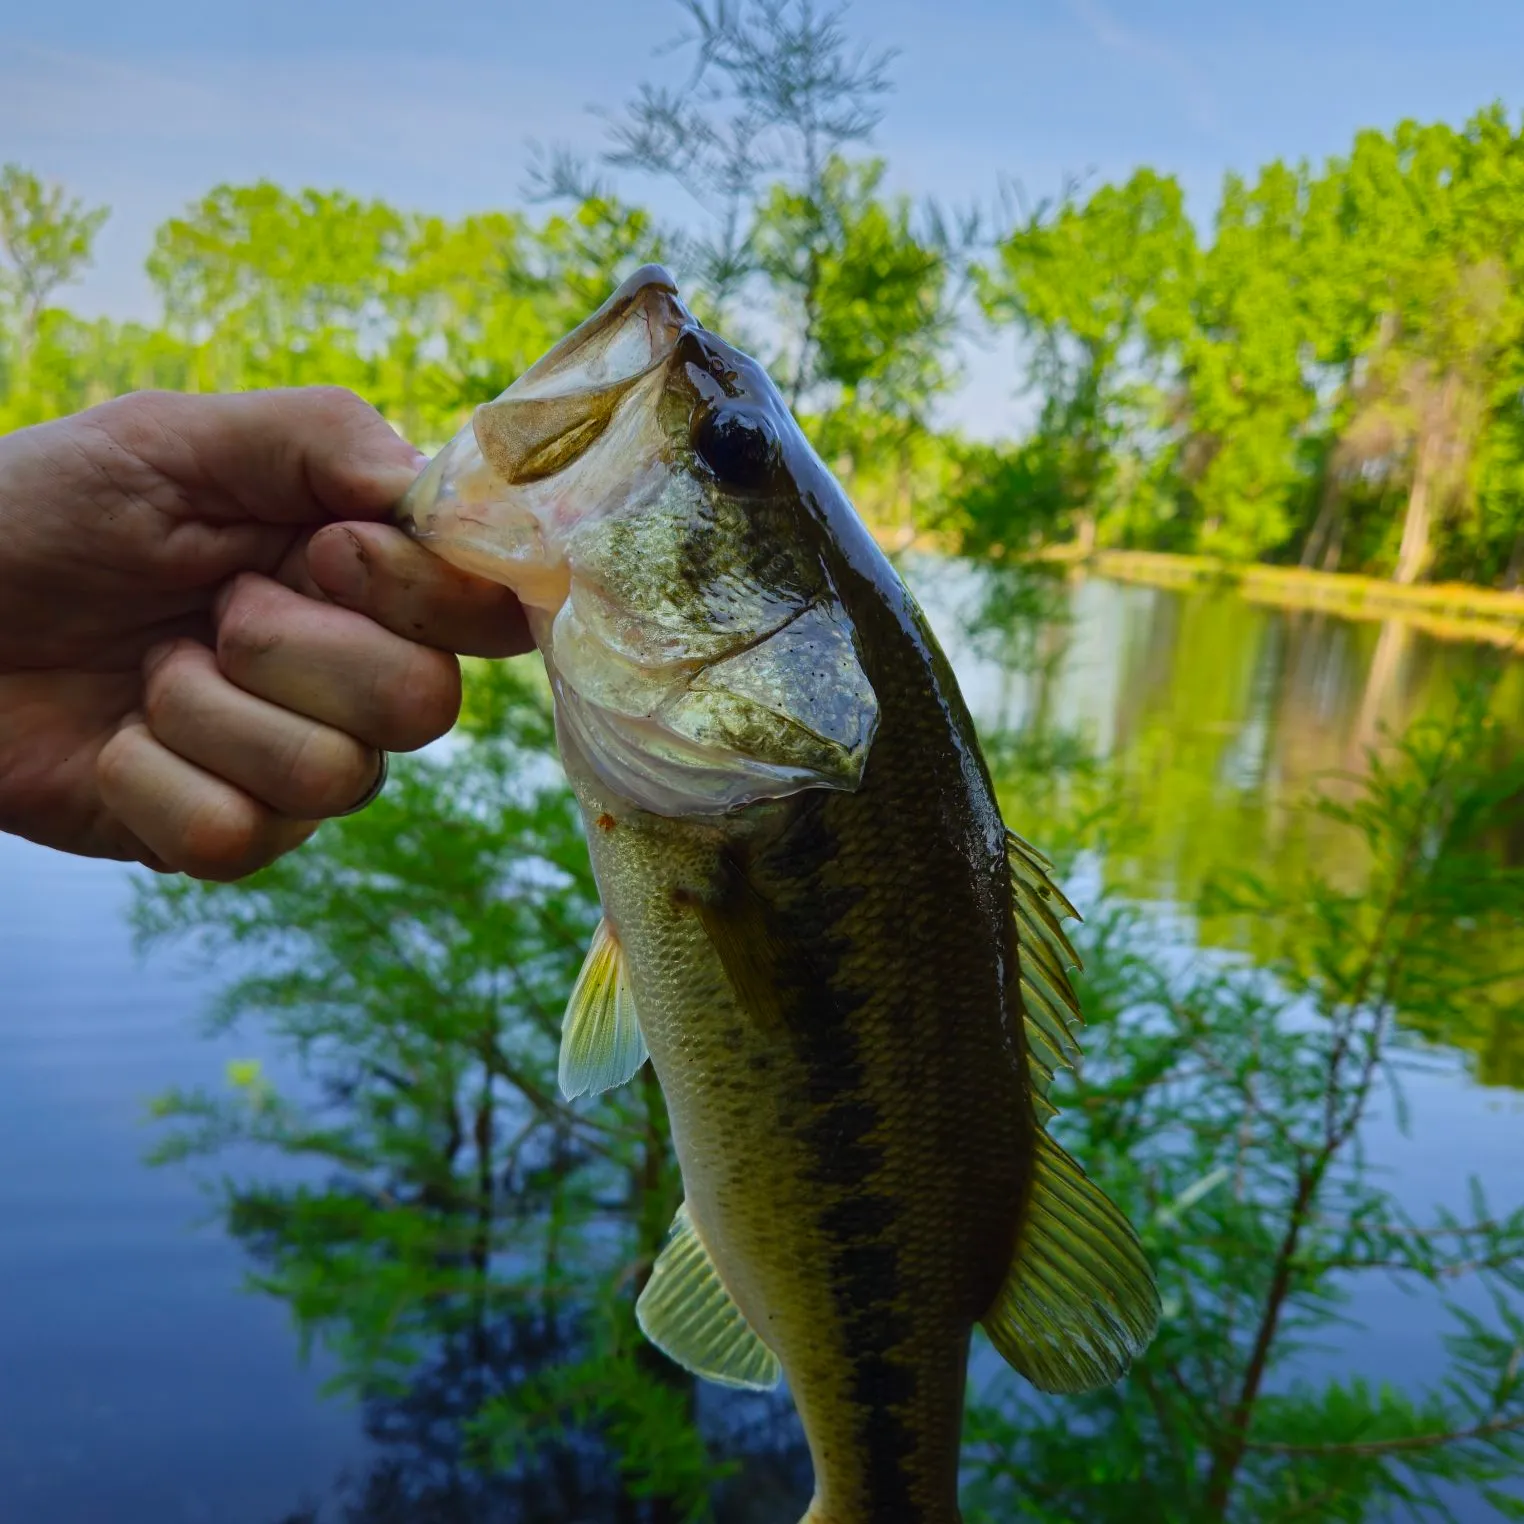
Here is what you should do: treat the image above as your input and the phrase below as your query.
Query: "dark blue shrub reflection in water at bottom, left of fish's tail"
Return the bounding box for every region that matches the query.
[280,1311,809,1524]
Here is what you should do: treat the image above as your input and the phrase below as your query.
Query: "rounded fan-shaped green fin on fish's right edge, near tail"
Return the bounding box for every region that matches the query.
[983,1128,1160,1391]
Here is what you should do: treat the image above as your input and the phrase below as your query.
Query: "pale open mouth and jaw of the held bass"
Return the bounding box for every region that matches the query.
[396,265,698,611]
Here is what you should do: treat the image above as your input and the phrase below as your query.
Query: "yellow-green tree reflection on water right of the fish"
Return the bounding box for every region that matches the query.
[911,562,1524,1087]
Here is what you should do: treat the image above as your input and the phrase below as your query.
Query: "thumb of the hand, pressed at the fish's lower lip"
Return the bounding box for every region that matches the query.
[85,386,425,524]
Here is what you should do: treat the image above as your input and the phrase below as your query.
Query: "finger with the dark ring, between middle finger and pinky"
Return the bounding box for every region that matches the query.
[143,640,381,820]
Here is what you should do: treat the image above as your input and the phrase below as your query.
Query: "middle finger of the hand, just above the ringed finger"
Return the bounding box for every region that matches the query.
[216,573,460,751]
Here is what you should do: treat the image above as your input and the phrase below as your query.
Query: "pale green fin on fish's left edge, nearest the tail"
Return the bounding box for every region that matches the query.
[636,1202,783,1391]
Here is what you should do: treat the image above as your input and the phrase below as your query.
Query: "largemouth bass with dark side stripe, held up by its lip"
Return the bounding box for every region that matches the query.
[399,265,1160,1524]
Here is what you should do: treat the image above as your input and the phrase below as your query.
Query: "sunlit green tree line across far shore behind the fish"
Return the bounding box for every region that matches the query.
[0,65,1524,587]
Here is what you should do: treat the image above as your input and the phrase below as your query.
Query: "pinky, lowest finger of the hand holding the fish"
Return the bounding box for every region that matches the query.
[96,715,317,882]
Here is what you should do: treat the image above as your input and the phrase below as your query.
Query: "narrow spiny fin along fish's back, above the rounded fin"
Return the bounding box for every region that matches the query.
[1006,831,1081,1103]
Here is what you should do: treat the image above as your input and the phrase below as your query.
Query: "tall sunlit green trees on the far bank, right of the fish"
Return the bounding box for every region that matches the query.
[972,107,1524,585]
